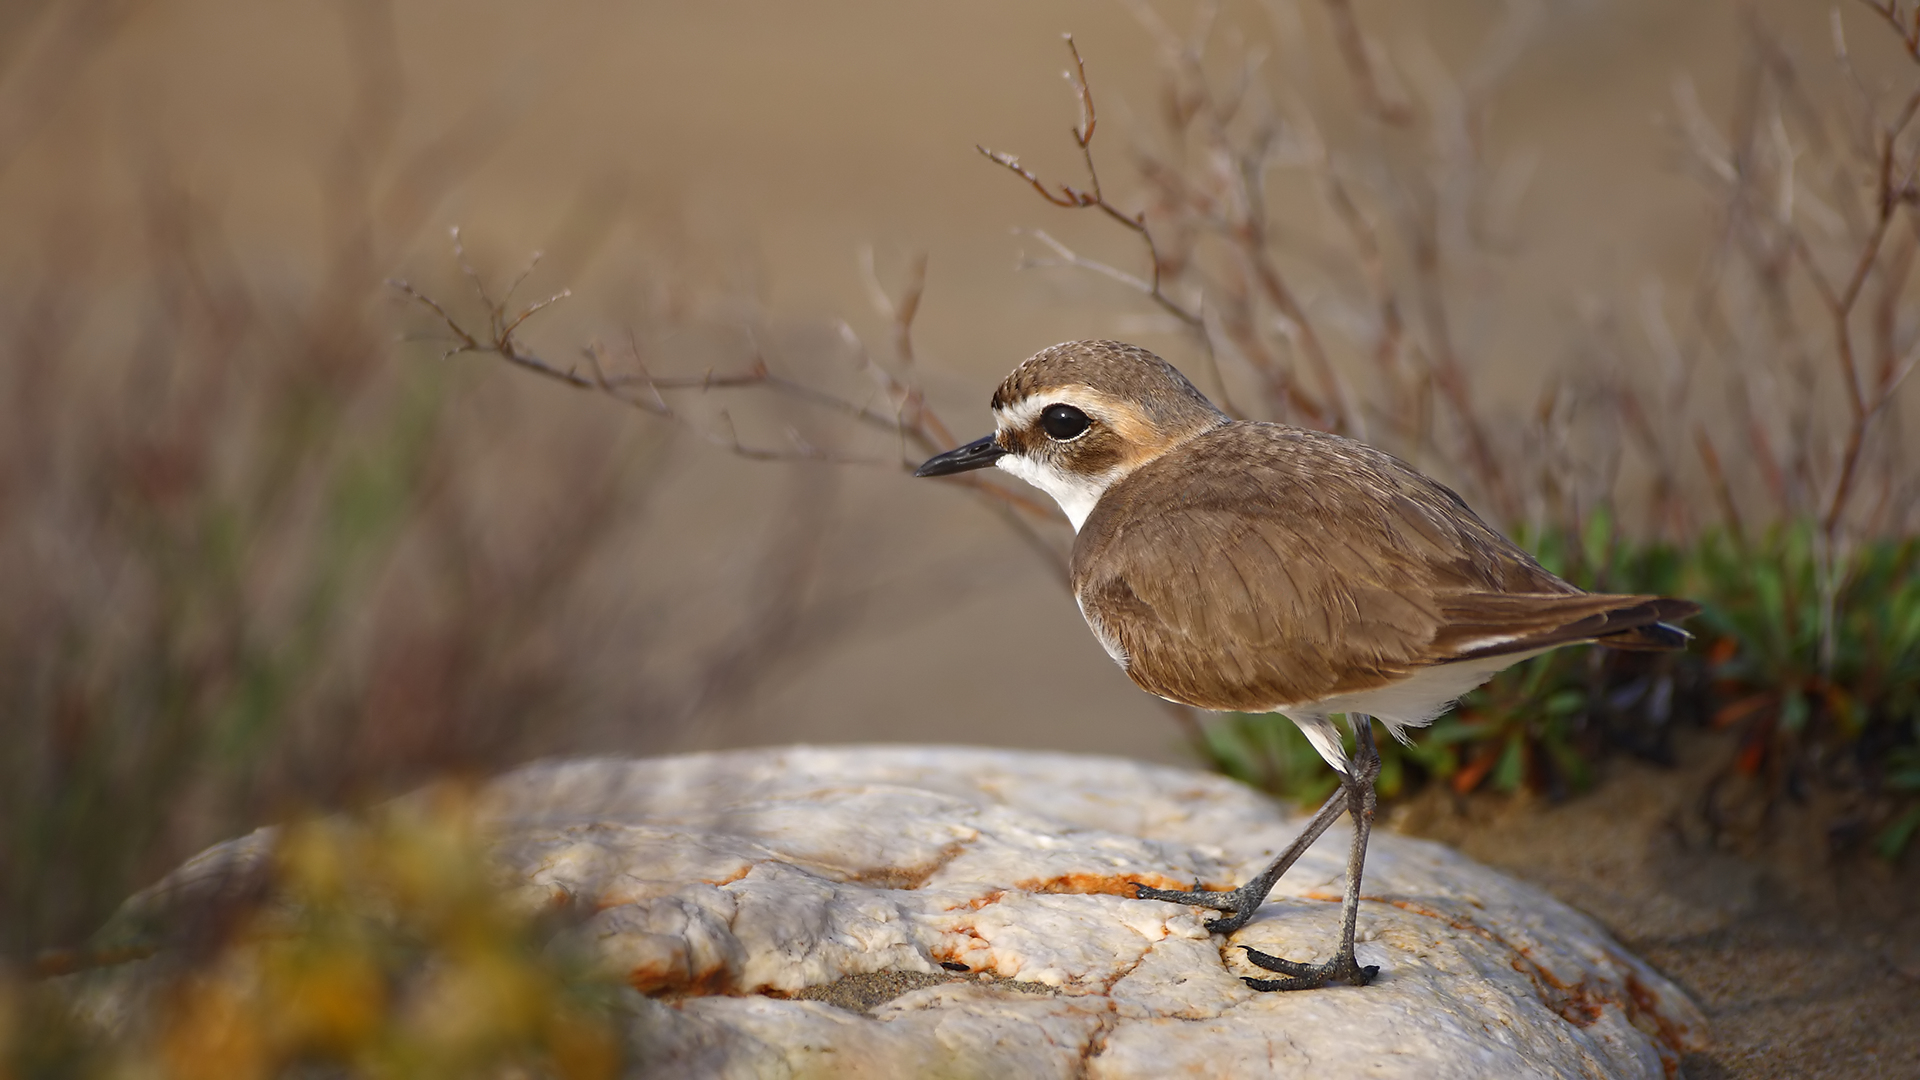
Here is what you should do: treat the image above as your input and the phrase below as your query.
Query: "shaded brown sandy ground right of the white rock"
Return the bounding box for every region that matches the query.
[1390,736,1920,1080]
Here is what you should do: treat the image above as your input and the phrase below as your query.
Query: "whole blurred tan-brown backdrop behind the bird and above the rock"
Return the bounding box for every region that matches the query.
[0,0,1920,1068]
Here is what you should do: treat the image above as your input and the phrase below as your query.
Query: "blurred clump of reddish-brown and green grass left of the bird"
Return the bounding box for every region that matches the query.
[0,62,636,953]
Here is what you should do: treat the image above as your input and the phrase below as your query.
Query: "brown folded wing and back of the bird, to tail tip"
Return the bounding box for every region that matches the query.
[1073,423,1695,709]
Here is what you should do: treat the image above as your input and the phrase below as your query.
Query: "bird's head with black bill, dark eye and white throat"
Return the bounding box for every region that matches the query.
[914,342,1227,530]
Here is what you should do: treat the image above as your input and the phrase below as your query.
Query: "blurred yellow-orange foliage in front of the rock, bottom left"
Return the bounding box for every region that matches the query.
[0,786,624,1080]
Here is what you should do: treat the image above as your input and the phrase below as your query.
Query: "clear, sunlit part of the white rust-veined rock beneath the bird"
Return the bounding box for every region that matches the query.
[112,748,1705,1080]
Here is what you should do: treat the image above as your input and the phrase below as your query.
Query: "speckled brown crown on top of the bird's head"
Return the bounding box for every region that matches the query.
[993,342,1227,429]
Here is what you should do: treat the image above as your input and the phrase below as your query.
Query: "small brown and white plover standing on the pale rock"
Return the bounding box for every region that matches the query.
[914,342,1699,990]
